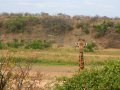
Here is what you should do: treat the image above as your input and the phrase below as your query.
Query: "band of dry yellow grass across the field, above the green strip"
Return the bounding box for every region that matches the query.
[0,48,120,63]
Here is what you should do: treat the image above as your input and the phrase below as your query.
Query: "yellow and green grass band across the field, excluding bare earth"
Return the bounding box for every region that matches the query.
[0,48,120,66]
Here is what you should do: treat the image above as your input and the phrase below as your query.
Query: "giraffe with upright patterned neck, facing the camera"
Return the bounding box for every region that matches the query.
[77,39,87,71]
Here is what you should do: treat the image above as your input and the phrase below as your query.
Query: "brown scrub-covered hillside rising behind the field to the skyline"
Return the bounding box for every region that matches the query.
[0,13,120,48]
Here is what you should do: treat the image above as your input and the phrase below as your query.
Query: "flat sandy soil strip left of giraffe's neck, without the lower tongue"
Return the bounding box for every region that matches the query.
[31,66,78,79]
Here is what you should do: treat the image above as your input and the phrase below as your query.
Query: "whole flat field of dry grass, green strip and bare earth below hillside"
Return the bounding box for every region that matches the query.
[0,48,120,90]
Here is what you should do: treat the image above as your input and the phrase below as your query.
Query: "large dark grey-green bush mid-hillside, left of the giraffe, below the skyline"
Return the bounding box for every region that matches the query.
[40,17,73,33]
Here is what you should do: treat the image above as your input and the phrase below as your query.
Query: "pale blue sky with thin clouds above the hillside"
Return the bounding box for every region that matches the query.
[0,0,120,17]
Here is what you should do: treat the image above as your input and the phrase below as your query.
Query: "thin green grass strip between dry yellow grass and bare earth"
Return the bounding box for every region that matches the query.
[0,56,77,66]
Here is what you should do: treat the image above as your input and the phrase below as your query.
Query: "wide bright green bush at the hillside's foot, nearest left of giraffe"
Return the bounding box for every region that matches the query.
[25,40,51,49]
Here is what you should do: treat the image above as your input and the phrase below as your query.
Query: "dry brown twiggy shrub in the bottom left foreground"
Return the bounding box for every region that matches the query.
[0,53,43,90]
